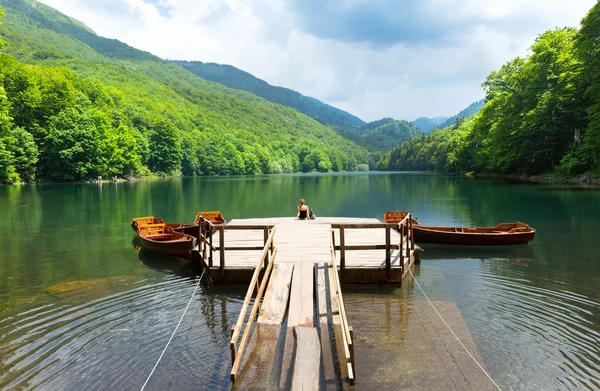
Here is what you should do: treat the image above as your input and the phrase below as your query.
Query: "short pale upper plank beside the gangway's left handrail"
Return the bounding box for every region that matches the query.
[257,263,294,324]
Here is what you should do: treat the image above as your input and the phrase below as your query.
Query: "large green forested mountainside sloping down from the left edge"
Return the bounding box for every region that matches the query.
[0,0,369,182]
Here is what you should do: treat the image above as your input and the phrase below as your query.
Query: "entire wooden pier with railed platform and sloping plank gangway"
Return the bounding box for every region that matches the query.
[192,215,419,390]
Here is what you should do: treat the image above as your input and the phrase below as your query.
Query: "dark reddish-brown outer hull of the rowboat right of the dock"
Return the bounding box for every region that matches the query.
[413,226,535,246]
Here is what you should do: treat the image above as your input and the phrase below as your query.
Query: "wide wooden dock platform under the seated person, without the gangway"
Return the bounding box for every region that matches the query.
[199,217,420,283]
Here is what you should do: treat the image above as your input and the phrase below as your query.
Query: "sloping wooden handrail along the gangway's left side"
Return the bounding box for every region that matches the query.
[230,227,277,381]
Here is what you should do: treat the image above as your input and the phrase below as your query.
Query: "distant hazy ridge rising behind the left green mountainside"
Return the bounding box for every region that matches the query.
[173,61,365,130]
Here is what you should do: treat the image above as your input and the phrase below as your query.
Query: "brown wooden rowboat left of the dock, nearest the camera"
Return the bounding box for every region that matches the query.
[137,223,194,259]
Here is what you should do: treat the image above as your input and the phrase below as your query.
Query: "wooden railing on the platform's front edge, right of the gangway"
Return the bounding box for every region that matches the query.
[331,213,415,279]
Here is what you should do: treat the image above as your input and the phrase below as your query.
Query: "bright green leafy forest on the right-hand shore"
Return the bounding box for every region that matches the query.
[378,3,600,177]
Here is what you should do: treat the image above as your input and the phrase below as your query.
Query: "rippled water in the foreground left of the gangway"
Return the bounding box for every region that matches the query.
[0,276,243,390]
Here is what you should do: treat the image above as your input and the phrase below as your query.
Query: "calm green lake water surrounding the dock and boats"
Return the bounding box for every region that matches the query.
[0,173,600,390]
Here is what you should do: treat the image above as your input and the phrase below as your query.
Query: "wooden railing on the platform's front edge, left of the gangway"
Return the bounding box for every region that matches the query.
[198,217,275,276]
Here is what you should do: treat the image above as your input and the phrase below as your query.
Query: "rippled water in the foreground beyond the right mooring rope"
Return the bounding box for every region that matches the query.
[414,258,600,390]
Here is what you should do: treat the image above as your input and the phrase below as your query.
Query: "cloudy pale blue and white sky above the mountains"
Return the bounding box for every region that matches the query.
[41,0,596,121]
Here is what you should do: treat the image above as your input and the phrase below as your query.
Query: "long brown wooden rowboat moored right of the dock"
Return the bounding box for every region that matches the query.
[383,211,535,246]
